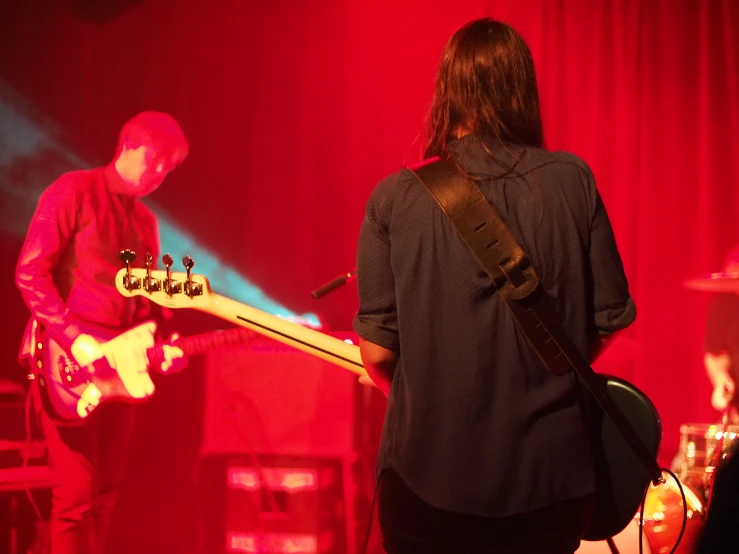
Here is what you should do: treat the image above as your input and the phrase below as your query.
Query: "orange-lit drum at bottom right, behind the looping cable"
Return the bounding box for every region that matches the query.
[637,475,705,554]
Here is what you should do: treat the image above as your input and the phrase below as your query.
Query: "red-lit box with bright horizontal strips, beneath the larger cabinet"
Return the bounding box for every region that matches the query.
[198,456,355,554]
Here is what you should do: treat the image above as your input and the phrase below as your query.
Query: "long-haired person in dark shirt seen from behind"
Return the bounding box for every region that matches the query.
[355,20,635,554]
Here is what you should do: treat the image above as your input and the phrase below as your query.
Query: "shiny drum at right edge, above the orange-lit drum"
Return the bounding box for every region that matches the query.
[672,423,739,494]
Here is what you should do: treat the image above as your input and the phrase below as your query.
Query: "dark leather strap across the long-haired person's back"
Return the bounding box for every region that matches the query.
[409,158,662,485]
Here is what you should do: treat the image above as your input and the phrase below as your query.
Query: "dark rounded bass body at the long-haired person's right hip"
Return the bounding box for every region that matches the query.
[584,374,662,541]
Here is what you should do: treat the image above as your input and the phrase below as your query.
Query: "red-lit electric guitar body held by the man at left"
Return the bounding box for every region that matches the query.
[34,324,154,425]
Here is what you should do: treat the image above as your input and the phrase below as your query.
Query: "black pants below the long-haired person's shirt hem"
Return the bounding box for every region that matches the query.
[378,470,594,554]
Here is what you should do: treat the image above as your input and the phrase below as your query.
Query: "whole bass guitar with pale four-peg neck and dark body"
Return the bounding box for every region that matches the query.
[108,260,662,541]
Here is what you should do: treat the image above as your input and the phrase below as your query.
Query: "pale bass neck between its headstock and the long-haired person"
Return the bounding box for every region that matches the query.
[197,294,367,375]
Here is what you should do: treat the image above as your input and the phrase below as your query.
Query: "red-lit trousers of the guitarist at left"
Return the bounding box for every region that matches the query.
[39,394,133,554]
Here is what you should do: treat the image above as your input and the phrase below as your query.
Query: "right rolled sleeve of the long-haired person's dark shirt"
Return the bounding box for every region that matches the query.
[585,169,636,334]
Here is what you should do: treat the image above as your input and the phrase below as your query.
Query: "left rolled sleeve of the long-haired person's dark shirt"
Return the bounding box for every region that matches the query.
[353,178,400,352]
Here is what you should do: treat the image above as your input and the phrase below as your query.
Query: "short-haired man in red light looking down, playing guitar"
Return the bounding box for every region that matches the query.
[16,112,188,554]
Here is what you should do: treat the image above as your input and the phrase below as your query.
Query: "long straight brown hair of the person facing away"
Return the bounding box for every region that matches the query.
[425,18,544,158]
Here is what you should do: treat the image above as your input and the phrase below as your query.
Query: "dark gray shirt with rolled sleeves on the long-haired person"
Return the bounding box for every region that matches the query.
[354,135,636,516]
